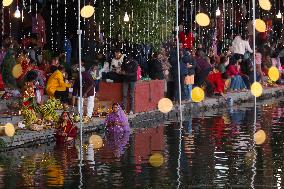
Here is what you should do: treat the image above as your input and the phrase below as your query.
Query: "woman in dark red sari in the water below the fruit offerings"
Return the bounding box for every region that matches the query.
[54,112,77,144]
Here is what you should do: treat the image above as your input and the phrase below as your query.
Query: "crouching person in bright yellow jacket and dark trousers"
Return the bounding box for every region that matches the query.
[46,66,71,104]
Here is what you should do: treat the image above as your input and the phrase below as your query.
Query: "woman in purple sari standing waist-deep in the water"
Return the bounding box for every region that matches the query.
[105,103,130,132]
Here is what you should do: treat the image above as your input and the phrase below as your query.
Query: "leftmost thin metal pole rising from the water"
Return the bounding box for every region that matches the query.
[77,0,83,165]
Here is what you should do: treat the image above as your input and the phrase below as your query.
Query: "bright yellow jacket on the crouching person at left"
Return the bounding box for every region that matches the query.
[46,70,71,97]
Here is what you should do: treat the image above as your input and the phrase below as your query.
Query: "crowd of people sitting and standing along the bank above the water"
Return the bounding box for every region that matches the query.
[0,26,284,125]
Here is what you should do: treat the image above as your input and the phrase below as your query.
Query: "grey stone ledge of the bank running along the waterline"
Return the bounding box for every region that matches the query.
[0,86,284,152]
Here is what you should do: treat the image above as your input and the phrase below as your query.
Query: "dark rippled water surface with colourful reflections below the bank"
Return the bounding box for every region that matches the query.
[0,99,284,189]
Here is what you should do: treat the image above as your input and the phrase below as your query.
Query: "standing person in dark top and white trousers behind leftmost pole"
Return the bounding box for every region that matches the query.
[72,68,95,121]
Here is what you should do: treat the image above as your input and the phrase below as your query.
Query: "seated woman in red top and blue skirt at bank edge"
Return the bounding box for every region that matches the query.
[226,58,246,91]
